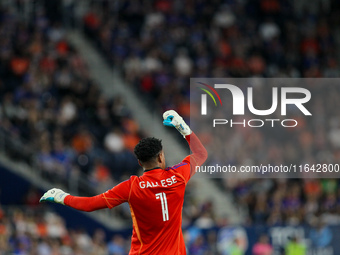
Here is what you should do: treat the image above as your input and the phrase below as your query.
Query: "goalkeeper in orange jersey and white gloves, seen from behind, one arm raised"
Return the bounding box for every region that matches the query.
[40,110,207,255]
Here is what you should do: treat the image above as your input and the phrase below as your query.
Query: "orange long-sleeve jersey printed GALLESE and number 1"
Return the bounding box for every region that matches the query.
[64,133,207,255]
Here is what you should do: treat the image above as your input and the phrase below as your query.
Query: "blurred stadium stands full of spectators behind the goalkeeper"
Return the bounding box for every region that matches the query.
[0,0,340,255]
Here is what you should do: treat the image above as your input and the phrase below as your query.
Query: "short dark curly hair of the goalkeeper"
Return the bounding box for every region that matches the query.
[134,137,163,163]
